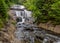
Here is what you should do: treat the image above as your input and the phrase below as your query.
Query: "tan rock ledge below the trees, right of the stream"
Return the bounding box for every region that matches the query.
[39,23,60,34]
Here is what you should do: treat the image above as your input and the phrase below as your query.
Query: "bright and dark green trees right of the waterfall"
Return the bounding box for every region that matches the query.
[24,0,60,24]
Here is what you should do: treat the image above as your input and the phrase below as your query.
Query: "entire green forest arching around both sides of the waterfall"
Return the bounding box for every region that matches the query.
[0,0,60,28]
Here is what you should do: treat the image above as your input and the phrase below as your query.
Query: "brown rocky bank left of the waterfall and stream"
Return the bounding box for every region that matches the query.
[0,11,16,43]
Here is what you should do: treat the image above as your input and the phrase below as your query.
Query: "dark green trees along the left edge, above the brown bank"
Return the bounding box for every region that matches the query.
[0,0,12,28]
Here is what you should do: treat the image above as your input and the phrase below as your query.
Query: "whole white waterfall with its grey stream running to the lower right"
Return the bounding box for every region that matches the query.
[11,6,60,43]
